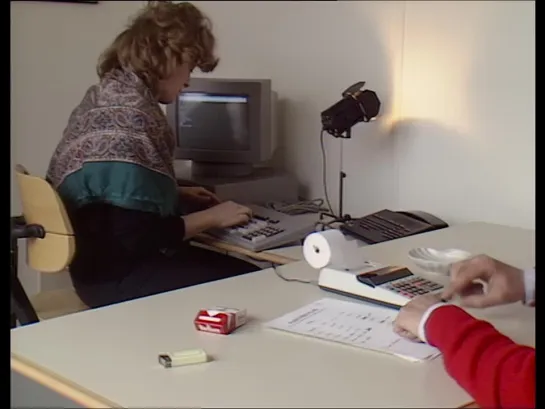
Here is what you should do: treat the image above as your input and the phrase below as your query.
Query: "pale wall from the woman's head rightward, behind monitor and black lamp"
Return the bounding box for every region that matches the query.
[191,1,535,227]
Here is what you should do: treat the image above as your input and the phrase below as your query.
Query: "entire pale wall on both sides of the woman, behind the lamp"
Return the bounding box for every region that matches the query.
[11,1,535,292]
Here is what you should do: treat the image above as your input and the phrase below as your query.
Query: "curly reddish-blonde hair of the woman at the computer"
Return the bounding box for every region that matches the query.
[97,1,218,91]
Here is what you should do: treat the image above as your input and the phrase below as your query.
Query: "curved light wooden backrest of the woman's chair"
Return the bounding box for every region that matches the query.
[15,165,76,273]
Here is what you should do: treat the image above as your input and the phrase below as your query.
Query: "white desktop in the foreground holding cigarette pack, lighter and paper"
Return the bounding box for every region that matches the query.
[11,223,535,408]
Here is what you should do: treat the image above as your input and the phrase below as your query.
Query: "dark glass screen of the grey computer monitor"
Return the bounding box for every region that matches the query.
[178,92,251,151]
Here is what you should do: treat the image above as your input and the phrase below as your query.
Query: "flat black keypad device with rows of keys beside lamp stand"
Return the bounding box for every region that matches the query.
[341,209,431,244]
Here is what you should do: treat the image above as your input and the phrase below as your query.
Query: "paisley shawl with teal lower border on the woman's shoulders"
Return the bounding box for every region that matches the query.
[47,70,178,215]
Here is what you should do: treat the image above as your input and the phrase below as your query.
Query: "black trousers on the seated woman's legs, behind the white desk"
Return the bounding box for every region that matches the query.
[72,246,259,308]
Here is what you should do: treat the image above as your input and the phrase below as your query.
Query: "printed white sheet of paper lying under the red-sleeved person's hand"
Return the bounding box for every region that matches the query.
[265,298,440,361]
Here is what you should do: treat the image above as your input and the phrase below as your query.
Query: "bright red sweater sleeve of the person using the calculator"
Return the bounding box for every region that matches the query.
[426,305,536,409]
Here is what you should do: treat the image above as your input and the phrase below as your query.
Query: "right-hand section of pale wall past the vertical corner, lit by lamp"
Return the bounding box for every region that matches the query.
[397,1,535,228]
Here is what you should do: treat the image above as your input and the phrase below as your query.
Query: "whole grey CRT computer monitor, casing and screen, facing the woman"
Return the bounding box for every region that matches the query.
[167,78,276,176]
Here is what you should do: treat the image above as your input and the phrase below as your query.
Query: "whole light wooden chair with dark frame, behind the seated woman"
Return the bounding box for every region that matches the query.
[11,165,88,326]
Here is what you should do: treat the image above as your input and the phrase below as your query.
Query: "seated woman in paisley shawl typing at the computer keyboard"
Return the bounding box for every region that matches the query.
[47,2,257,307]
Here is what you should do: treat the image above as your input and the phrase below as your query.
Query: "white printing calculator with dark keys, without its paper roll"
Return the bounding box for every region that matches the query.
[318,266,443,309]
